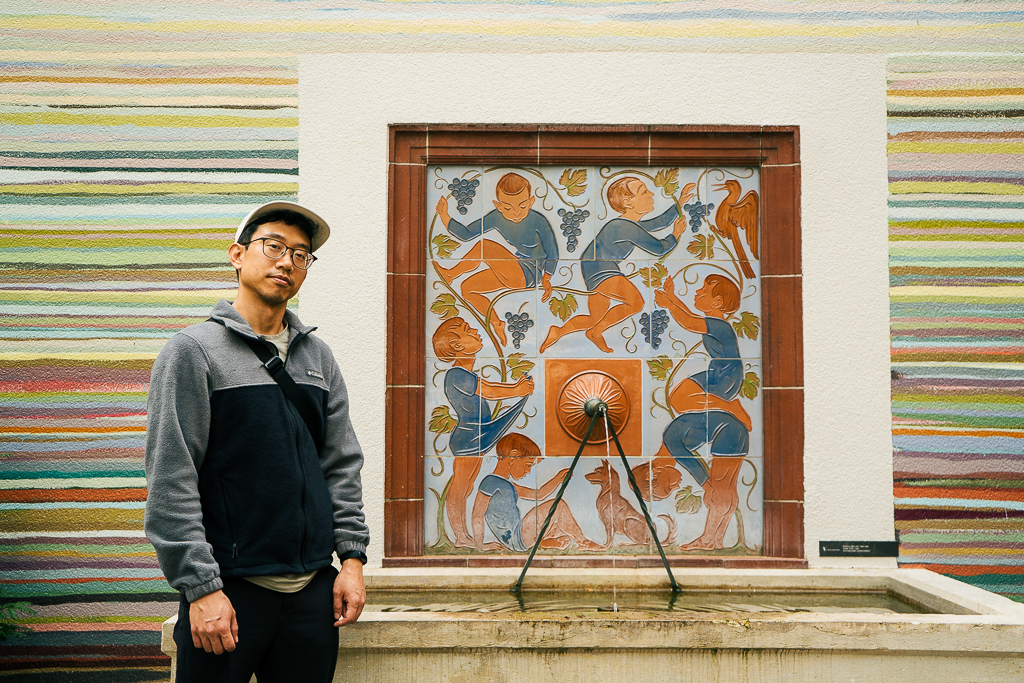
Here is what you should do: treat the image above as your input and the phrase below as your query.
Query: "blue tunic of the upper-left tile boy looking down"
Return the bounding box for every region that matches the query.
[447,209,558,287]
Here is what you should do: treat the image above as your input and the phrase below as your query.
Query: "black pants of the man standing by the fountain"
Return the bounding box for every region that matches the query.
[174,567,338,683]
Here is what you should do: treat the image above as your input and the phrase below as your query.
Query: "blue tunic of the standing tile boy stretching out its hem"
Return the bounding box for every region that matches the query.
[444,368,528,456]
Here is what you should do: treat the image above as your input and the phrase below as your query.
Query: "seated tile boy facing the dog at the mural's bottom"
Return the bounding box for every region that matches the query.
[473,432,603,552]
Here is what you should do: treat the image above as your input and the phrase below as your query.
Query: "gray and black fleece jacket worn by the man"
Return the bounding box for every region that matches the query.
[145,300,370,602]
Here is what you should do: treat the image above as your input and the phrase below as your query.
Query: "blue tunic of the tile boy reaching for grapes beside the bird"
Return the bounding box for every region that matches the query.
[581,204,679,292]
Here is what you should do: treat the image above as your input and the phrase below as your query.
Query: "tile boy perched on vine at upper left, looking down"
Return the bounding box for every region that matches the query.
[434,173,558,346]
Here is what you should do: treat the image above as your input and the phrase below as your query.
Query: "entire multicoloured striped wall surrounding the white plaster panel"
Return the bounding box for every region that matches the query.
[0,0,1024,682]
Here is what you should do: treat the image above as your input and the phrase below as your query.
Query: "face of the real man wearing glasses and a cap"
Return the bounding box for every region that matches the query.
[231,220,309,306]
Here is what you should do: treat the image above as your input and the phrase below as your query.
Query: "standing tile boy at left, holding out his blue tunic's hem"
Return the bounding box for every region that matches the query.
[431,317,534,548]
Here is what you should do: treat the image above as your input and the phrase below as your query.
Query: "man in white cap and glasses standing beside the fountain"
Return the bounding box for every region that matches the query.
[145,202,370,683]
